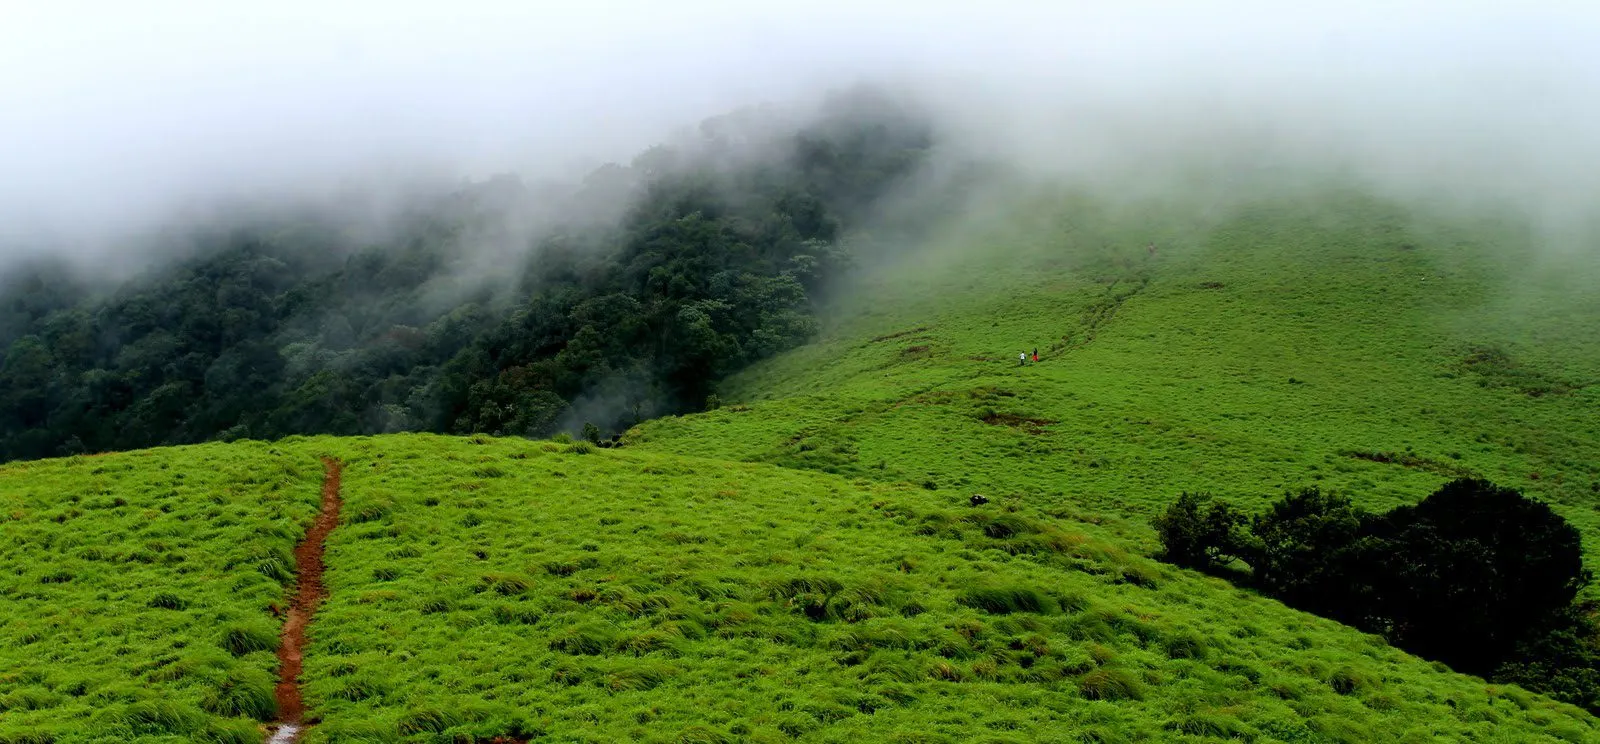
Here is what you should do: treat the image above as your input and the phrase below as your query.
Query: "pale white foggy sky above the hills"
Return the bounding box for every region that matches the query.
[0,0,1600,253]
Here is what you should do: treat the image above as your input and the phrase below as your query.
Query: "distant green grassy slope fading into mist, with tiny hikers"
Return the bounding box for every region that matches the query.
[630,192,1600,565]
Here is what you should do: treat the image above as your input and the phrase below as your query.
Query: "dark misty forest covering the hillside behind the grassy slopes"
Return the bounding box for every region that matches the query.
[0,88,933,459]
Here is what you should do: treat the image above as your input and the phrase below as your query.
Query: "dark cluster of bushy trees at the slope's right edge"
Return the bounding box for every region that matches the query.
[1155,478,1600,710]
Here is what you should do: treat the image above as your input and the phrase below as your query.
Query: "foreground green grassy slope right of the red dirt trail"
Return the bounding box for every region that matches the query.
[294,435,1597,742]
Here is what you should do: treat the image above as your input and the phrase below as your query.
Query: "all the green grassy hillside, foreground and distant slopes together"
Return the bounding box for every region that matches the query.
[0,187,1600,742]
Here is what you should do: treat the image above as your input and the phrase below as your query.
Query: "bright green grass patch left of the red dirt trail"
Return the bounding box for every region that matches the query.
[0,443,322,744]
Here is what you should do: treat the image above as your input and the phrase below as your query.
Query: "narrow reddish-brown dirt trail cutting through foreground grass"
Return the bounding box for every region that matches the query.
[270,458,344,742]
